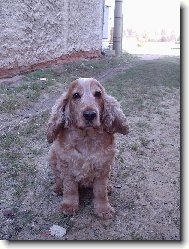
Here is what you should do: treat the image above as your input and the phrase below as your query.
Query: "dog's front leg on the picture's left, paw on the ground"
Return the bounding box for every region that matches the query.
[60,176,79,215]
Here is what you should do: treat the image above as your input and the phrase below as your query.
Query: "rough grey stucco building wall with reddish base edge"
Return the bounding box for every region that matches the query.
[0,0,104,77]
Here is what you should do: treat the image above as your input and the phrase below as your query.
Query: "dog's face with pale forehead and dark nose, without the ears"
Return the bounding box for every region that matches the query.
[67,78,104,129]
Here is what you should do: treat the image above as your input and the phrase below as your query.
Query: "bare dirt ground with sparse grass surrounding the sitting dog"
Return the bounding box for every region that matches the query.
[0,55,181,240]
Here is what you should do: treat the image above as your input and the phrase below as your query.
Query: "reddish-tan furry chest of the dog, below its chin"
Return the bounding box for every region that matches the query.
[58,129,115,186]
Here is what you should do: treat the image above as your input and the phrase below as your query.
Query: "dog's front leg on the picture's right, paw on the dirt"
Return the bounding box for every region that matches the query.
[93,178,115,219]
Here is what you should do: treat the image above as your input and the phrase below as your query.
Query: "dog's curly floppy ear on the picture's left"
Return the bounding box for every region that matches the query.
[47,93,70,143]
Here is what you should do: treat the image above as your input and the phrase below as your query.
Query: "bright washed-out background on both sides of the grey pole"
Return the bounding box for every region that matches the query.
[103,0,180,55]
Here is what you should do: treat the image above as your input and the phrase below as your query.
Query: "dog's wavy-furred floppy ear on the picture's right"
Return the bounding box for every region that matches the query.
[102,94,129,135]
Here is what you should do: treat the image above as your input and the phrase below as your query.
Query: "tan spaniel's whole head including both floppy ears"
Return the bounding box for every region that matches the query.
[47,78,128,142]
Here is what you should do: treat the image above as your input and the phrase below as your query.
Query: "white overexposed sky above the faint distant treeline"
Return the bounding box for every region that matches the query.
[122,0,180,34]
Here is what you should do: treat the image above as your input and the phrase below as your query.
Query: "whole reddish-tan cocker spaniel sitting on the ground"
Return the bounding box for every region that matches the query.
[47,78,129,218]
